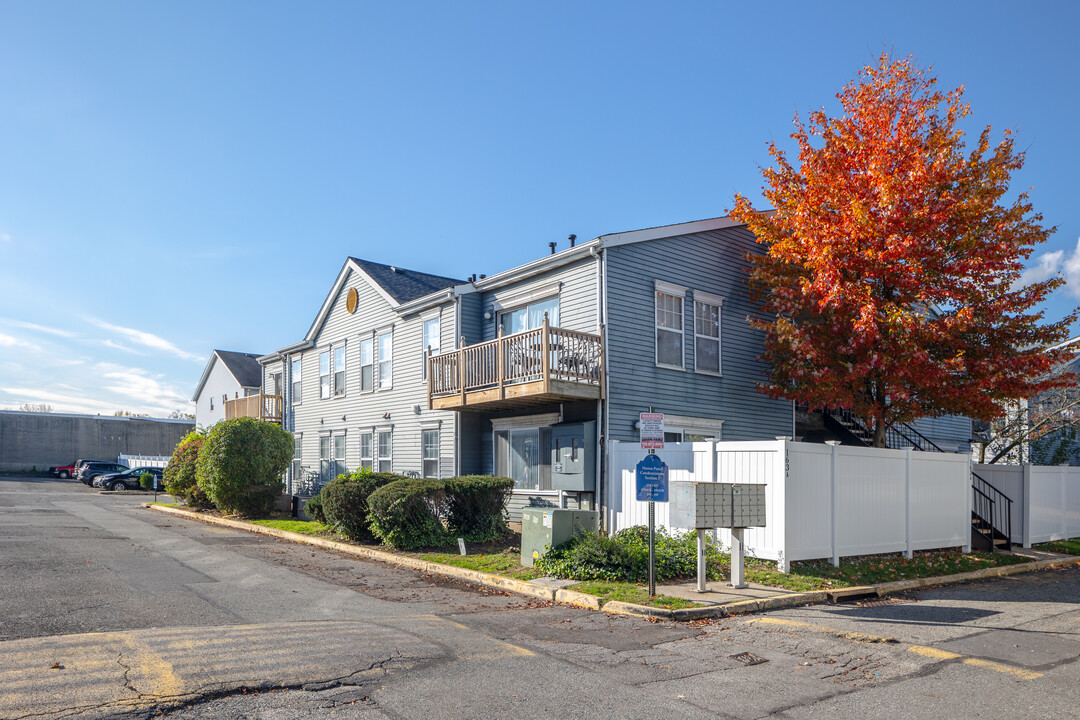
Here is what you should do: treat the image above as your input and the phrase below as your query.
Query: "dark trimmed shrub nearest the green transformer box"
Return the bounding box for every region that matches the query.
[445,475,514,543]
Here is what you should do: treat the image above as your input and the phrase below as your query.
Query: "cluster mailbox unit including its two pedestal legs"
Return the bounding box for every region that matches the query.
[669,481,766,593]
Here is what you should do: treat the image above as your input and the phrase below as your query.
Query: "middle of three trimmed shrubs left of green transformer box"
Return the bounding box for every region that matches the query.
[367,478,450,549]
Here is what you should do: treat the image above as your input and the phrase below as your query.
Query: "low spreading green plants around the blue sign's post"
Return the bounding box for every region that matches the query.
[536,526,727,583]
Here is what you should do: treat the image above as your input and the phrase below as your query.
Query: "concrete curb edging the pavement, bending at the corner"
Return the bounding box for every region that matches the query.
[143,503,1080,622]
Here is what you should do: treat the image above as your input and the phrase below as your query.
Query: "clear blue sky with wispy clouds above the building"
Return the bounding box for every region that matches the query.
[0,0,1080,416]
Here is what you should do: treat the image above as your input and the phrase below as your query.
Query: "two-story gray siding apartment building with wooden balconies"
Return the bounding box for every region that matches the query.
[259,217,970,519]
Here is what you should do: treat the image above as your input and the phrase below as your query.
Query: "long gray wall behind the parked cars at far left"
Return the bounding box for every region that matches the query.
[0,410,194,470]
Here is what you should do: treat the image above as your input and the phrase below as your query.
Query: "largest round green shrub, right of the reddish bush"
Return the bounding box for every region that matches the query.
[195,418,293,517]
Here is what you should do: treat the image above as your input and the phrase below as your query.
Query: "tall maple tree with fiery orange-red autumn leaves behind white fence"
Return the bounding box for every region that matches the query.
[731,54,1077,447]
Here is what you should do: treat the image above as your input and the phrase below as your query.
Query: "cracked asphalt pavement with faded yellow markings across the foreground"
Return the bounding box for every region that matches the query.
[0,478,1080,720]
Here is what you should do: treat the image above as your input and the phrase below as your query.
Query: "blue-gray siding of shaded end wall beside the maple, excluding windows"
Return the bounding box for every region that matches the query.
[606,228,794,441]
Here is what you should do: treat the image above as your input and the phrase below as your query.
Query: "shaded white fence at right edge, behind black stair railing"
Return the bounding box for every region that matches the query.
[973,464,1080,547]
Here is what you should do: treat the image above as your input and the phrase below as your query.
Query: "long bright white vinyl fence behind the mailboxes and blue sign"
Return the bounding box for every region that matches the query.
[606,439,976,572]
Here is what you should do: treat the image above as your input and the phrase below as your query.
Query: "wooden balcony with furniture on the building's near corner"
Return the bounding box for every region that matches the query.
[428,317,604,410]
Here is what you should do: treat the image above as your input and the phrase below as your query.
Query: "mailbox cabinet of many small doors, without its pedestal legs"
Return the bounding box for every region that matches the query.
[667,481,765,530]
